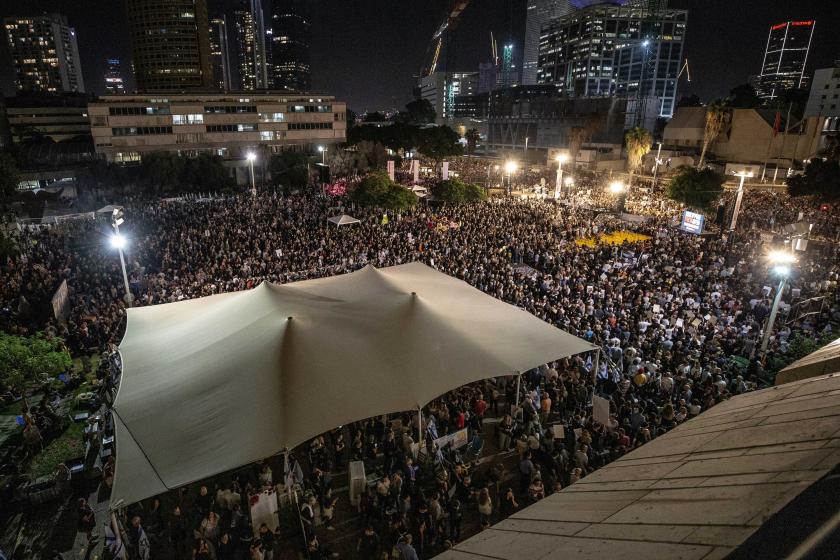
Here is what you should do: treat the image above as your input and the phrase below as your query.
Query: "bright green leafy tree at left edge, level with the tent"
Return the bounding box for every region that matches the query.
[0,332,73,406]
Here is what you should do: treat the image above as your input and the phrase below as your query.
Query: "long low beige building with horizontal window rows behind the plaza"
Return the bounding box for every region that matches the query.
[88,92,347,163]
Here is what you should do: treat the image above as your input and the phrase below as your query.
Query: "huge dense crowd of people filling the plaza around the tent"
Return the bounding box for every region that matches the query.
[0,172,840,560]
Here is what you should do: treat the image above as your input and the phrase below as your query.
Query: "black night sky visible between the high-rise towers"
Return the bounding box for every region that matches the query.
[0,0,840,112]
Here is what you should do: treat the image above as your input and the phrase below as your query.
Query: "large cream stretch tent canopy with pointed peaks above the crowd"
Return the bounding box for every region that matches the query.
[111,263,596,507]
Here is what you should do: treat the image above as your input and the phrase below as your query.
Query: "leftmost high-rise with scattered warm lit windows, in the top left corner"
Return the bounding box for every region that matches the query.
[4,14,85,93]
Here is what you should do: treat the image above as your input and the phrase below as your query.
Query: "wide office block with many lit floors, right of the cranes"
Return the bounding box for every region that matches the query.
[537,1,688,118]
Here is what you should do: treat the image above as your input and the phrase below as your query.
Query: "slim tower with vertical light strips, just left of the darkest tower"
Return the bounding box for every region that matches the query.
[233,0,270,91]
